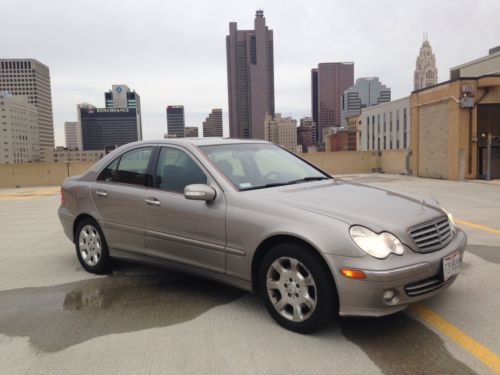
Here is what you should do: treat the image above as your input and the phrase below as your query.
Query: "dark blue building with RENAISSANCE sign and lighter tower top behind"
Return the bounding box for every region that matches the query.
[77,85,142,151]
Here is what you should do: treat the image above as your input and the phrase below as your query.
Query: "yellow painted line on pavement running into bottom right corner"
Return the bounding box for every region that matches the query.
[410,303,500,374]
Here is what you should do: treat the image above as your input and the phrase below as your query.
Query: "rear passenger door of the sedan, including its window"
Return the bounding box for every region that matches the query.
[91,146,154,253]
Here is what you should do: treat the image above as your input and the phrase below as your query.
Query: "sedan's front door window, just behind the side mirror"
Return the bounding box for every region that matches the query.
[154,147,207,193]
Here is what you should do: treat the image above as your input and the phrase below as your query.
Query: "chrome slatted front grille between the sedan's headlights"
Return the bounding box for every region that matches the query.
[410,216,452,253]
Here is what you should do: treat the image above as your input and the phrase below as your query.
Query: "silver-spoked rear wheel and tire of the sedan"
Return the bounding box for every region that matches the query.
[75,218,111,274]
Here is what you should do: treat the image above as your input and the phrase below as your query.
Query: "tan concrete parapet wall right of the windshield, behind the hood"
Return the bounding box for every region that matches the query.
[301,150,407,175]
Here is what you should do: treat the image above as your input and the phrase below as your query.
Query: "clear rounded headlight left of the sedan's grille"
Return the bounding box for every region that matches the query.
[349,225,404,259]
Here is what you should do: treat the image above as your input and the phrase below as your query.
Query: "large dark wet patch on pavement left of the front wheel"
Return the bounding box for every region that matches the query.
[0,273,245,352]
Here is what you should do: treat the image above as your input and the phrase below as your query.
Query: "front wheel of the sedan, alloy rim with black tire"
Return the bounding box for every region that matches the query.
[258,242,338,333]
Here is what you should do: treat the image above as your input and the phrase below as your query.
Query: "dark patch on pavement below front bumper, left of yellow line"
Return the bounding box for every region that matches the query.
[340,312,475,375]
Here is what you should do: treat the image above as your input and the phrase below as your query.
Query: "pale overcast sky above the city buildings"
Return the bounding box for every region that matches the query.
[0,1,500,145]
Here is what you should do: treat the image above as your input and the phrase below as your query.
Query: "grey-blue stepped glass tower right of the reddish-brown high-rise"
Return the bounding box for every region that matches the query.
[340,77,391,126]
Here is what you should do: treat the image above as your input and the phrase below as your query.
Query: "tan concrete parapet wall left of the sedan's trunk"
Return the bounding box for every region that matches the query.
[0,161,95,188]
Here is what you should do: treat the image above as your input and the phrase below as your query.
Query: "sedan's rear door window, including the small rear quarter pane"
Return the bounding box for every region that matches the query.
[98,147,153,186]
